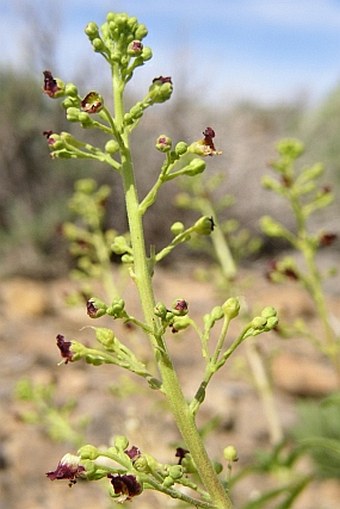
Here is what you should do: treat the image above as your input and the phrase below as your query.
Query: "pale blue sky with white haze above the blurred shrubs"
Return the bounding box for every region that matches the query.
[0,0,340,102]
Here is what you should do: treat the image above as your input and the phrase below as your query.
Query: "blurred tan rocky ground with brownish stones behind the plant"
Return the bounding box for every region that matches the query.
[0,267,340,509]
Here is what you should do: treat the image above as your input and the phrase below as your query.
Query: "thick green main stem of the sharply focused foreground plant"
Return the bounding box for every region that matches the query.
[113,69,232,509]
